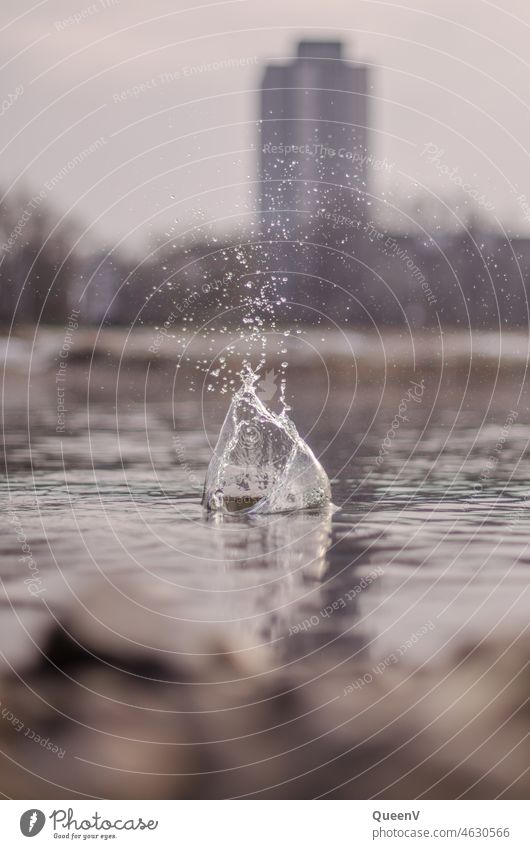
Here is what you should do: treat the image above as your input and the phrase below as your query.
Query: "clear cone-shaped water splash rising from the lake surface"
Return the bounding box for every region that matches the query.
[203,379,331,514]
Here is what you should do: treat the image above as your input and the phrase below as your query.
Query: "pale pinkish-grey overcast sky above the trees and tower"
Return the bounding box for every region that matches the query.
[0,0,530,249]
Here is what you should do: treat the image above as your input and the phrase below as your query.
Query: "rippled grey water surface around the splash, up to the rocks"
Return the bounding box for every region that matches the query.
[0,328,530,676]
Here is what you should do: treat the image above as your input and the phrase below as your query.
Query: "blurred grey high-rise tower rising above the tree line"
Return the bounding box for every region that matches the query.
[260,41,369,217]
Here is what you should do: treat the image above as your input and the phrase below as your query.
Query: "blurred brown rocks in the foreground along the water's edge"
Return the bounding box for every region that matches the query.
[0,587,530,799]
